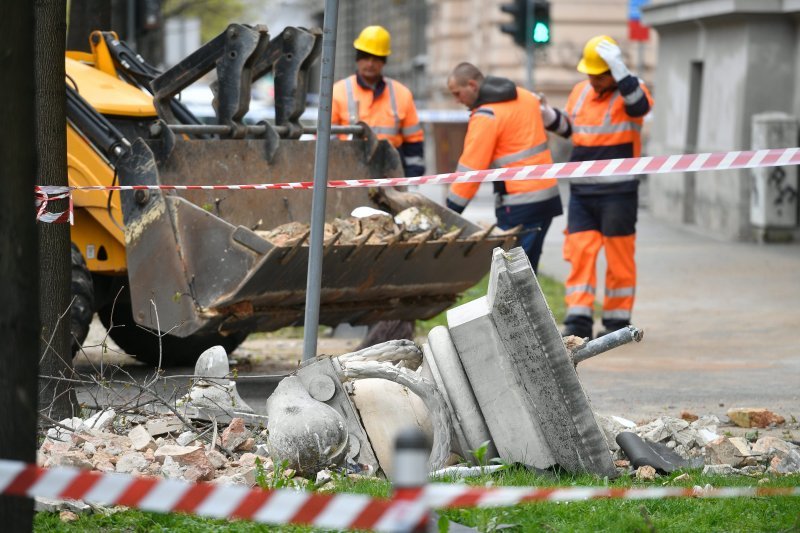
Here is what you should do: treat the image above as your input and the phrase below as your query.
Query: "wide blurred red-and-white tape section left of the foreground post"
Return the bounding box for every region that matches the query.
[0,460,427,531]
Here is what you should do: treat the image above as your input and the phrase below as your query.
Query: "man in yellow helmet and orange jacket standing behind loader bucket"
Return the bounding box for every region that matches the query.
[331,26,425,176]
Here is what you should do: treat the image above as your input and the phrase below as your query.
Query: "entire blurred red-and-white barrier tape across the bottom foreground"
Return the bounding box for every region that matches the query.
[0,459,800,531]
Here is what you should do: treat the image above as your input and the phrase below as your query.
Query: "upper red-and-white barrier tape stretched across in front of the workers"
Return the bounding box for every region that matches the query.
[34,148,800,222]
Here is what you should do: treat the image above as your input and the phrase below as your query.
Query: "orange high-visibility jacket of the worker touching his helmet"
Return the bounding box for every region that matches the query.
[566,80,653,184]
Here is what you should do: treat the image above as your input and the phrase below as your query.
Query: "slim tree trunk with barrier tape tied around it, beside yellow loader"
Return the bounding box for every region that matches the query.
[34,0,78,420]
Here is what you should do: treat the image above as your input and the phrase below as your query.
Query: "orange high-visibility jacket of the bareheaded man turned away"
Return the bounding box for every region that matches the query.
[447,86,558,206]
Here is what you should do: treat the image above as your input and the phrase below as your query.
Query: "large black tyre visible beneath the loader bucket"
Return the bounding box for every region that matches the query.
[97,286,247,367]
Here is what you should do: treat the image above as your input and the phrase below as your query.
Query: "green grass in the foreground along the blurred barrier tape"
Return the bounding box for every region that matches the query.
[34,468,800,532]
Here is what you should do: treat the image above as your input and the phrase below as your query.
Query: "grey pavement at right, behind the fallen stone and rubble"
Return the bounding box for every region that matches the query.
[450,188,800,420]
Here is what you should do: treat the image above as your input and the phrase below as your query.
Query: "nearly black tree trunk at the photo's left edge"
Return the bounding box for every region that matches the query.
[0,2,39,532]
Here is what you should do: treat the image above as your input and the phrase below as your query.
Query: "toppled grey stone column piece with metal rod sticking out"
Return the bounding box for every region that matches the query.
[267,248,641,477]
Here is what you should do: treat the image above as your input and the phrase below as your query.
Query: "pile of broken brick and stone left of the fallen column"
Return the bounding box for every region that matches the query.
[37,415,378,519]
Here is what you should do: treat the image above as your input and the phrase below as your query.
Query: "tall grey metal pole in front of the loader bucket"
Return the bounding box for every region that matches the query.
[303,0,339,361]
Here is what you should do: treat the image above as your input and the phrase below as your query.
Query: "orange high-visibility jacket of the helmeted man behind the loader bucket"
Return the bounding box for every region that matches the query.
[331,74,424,148]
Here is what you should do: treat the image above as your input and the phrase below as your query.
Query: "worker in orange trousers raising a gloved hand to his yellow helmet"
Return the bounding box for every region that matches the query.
[543,35,653,338]
